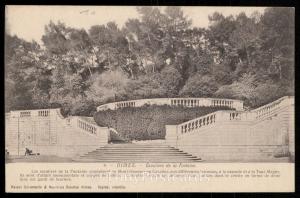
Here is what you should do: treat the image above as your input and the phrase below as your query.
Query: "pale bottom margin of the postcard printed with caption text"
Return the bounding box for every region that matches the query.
[6,163,293,192]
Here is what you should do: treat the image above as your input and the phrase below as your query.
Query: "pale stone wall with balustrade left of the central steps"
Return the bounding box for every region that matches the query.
[5,109,109,157]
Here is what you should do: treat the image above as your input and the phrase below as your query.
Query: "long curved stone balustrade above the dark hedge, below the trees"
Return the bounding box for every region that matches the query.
[97,98,243,111]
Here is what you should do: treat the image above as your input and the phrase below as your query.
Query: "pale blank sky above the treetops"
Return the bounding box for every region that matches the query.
[6,6,264,43]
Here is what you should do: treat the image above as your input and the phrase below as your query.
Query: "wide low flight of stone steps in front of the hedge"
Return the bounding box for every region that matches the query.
[74,143,202,163]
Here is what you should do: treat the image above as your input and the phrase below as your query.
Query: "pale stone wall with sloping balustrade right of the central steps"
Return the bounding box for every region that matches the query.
[166,97,294,160]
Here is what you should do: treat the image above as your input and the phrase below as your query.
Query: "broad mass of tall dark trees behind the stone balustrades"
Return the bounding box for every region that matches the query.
[5,7,295,115]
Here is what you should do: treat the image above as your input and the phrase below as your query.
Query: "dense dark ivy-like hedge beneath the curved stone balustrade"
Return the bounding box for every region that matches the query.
[94,105,229,140]
